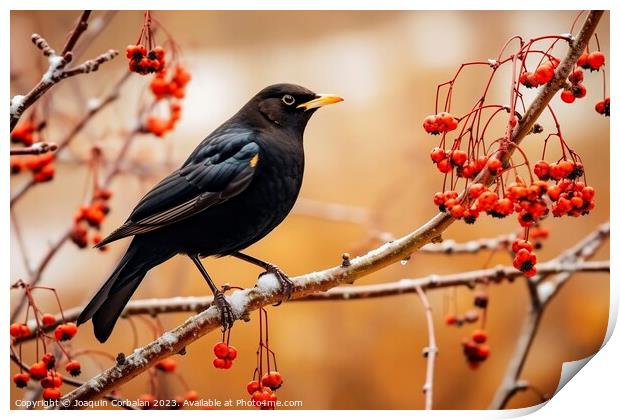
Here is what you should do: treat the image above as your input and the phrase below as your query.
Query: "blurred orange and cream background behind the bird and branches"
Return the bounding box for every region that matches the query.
[10,11,609,409]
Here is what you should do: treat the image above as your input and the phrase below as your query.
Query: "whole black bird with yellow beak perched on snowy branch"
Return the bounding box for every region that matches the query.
[78,84,342,342]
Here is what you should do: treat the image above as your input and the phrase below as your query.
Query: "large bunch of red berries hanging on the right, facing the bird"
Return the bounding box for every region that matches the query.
[422,22,609,278]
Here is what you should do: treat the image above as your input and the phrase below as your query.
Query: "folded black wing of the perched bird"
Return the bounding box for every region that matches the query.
[98,129,260,246]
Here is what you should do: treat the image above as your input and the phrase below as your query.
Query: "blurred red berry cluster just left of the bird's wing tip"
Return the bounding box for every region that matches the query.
[71,188,112,251]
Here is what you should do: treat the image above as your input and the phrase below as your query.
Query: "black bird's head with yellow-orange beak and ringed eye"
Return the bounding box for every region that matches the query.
[247,83,343,134]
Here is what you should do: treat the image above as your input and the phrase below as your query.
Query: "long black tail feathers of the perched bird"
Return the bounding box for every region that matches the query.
[77,238,174,343]
